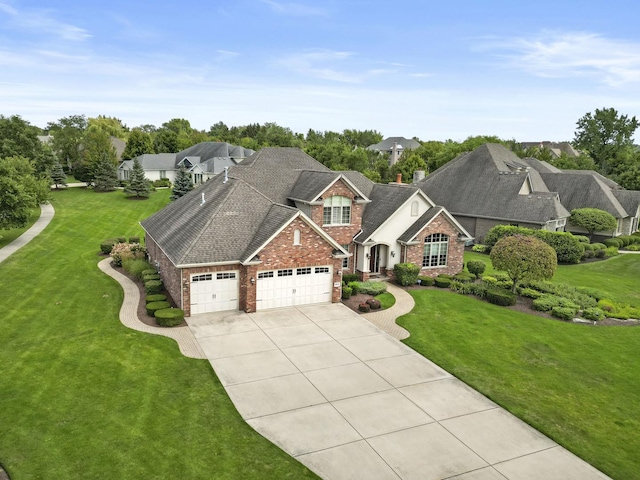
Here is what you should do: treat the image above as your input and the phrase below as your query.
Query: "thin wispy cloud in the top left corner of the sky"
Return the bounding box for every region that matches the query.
[0,3,91,42]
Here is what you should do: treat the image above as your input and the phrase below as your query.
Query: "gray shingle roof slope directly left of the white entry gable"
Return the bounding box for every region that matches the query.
[356,183,418,243]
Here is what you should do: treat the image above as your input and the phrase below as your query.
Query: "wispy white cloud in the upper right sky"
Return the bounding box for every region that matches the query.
[478,32,640,86]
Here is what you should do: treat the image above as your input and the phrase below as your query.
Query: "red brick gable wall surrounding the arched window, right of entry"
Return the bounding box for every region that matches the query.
[402,214,464,277]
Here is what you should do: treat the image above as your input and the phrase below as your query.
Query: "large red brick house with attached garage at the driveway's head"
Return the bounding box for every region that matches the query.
[142,148,468,315]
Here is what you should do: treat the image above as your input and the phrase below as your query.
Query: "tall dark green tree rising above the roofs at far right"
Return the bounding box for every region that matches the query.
[573,108,638,175]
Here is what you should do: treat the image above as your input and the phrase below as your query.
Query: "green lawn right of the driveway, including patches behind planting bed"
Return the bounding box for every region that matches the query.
[398,253,640,479]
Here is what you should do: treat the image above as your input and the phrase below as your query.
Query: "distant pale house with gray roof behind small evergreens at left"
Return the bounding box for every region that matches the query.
[118,142,254,184]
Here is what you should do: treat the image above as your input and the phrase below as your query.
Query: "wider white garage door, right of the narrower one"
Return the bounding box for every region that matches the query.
[256,266,333,310]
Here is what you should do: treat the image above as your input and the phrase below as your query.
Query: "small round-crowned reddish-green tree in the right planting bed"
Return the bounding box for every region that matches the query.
[490,235,558,293]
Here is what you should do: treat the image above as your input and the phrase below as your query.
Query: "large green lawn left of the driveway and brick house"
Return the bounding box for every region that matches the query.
[0,189,316,480]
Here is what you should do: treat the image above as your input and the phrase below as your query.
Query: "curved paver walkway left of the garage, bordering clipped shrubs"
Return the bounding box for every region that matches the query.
[98,258,207,359]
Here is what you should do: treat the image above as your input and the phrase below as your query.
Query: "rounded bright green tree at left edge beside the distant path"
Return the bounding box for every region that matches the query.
[0,157,50,230]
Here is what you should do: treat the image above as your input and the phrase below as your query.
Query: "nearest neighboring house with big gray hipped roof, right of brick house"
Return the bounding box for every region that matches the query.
[417,143,570,241]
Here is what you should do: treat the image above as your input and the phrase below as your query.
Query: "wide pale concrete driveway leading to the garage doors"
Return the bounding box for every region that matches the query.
[188,304,608,480]
